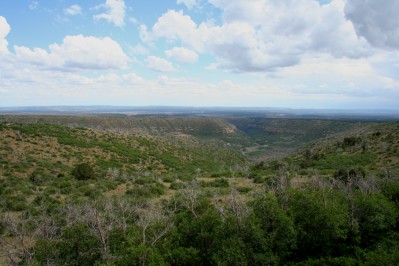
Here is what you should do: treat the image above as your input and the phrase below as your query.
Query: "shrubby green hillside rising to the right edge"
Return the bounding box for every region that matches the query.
[293,123,399,177]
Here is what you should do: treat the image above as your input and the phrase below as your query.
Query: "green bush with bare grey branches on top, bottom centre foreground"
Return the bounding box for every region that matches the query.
[163,192,222,265]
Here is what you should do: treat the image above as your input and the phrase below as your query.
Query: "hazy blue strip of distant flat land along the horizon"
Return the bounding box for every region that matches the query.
[0,105,399,120]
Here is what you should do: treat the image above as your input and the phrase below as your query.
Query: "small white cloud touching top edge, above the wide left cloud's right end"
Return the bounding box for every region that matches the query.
[94,0,126,27]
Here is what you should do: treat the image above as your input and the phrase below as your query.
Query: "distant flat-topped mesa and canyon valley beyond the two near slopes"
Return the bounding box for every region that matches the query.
[0,115,375,161]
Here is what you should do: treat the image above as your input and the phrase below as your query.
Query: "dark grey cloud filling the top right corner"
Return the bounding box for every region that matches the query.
[345,0,399,49]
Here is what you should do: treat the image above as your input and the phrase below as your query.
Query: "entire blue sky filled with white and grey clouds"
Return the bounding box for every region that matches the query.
[0,0,399,110]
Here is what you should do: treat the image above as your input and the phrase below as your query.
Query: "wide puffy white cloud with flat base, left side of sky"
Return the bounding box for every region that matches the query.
[14,35,128,69]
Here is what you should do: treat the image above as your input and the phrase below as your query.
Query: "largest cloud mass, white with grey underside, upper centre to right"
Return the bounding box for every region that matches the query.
[141,0,370,72]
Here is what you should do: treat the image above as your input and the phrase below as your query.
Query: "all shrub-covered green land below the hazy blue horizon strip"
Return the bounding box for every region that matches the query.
[0,117,399,265]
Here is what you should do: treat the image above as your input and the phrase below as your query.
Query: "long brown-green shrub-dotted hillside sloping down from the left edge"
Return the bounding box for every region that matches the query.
[0,123,244,178]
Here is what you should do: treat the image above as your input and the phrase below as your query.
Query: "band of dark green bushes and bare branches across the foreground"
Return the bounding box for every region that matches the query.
[3,176,399,265]
